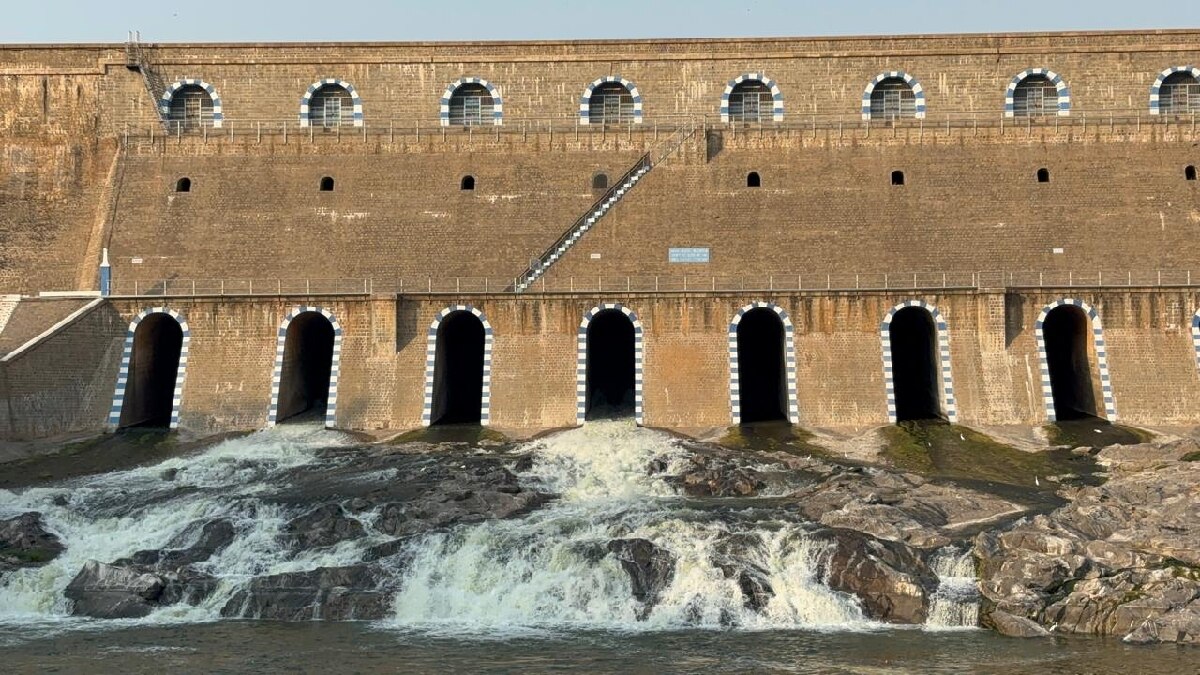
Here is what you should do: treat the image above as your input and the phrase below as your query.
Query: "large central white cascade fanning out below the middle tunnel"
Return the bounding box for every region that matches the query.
[394,420,871,632]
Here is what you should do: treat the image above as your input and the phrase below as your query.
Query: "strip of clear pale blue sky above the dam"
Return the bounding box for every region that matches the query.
[0,0,1200,42]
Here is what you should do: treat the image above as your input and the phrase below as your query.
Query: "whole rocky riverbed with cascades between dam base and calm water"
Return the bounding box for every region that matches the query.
[0,422,1200,643]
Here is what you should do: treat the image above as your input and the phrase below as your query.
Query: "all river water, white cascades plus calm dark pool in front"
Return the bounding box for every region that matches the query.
[0,422,1198,673]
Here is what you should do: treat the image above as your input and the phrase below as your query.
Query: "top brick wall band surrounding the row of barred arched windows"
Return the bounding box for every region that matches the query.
[0,30,1200,130]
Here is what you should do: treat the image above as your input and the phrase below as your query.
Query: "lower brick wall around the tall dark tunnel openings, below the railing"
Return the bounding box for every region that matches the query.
[84,288,1200,434]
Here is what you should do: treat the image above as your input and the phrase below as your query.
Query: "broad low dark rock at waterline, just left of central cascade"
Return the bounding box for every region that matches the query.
[221,565,395,621]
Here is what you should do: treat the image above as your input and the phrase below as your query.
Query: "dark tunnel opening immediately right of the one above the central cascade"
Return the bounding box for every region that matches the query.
[738,307,787,424]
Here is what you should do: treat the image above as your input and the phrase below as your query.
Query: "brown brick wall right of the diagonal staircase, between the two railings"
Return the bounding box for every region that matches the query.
[547,130,1200,283]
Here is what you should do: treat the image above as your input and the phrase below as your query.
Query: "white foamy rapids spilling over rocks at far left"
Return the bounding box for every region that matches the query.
[0,425,377,622]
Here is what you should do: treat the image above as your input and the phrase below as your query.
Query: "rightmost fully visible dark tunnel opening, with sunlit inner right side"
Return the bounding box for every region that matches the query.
[1042,305,1099,420]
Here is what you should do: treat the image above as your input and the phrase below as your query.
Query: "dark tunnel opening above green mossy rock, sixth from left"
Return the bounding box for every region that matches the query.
[888,307,942,422]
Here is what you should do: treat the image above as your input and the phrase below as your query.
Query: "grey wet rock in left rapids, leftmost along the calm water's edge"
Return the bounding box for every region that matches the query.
[64,560,217,619]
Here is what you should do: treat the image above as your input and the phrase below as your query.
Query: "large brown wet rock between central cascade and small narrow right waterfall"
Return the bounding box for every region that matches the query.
[816,530,937,623]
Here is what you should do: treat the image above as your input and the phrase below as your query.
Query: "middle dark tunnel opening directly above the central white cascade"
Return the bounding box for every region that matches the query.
[587,310,635,419]
